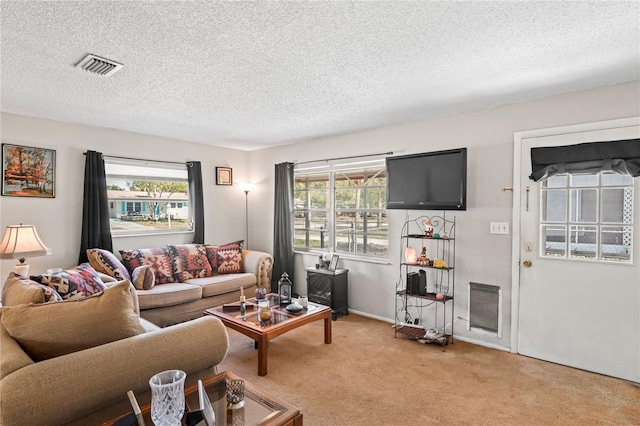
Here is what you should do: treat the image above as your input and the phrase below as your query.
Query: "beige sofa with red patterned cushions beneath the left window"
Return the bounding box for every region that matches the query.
[87,241,273,327]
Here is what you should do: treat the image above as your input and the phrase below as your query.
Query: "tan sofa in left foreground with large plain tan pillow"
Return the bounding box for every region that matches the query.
[0,274,229,426]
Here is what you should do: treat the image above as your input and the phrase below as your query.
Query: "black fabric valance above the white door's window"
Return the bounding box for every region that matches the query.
[529,139,640,182]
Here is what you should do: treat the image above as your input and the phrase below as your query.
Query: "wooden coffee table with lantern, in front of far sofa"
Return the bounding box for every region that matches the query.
[204,293,331,376]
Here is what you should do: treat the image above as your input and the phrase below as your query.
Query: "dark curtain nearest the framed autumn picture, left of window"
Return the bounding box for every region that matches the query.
[79,151,113,263]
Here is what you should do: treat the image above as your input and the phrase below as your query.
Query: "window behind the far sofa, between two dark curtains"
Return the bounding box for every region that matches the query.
[105,157,192,236]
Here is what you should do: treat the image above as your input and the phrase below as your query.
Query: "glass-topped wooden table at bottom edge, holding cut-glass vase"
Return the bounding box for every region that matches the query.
[103,371,303,426]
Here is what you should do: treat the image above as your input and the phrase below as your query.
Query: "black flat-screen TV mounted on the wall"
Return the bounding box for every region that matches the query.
[386,148,467,210]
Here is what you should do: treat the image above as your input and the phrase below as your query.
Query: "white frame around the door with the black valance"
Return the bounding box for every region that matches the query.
[511,116,640,353]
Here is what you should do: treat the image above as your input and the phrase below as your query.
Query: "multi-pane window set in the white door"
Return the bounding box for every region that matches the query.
[540,172,633,263]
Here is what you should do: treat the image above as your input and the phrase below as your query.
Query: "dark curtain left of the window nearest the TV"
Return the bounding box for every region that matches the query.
[271,163,294,292]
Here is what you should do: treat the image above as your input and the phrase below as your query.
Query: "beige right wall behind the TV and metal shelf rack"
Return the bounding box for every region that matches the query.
[249,82,640,348]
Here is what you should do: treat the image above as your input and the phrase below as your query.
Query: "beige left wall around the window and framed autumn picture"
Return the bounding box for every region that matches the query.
[0,114,248,277]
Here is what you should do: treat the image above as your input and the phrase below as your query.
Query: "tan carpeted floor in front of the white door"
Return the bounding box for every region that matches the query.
[220,314,640,426]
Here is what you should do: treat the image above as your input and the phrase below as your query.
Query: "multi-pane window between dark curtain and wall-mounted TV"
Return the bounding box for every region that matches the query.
[294,161,389,258]
